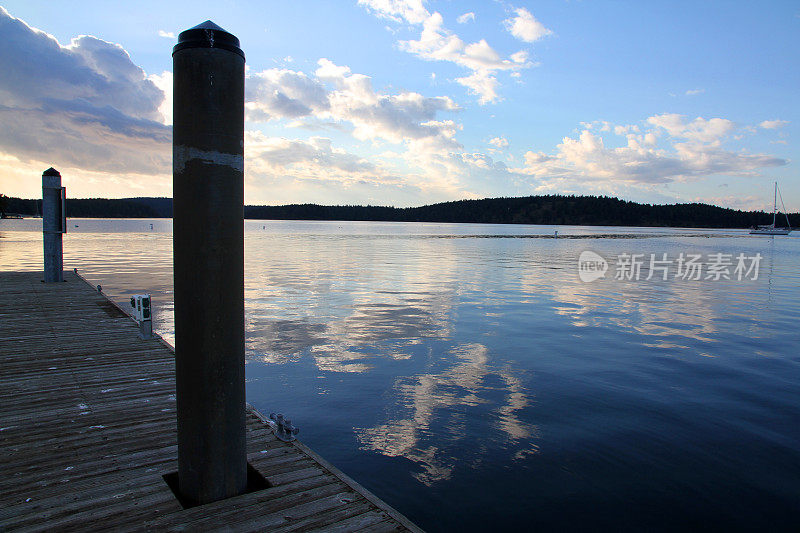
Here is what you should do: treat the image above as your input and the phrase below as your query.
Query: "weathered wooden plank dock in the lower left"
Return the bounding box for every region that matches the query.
[0,272,420,532]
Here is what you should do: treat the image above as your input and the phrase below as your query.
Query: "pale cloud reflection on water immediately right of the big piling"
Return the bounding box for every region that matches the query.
[245,235,456,372]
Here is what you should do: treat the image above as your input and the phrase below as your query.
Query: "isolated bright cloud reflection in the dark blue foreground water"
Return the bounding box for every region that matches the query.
[356,344,536,486]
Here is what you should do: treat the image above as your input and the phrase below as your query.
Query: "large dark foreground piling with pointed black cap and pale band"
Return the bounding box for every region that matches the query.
[172,21,247,504]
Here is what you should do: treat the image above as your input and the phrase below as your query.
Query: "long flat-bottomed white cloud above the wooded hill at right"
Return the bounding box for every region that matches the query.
[515,114,787,184]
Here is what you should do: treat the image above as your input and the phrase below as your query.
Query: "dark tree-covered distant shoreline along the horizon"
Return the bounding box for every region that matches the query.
[3,195,800,229]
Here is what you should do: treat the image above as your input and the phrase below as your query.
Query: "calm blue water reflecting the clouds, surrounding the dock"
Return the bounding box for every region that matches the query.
[0,219,800,531]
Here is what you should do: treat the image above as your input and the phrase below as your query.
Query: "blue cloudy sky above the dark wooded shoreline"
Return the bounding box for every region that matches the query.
[0,0,800,211]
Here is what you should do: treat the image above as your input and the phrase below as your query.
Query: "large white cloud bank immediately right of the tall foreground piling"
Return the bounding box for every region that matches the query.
[245,58,472,203]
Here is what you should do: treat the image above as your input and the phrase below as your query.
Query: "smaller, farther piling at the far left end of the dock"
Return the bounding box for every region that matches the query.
[42,167,67,283]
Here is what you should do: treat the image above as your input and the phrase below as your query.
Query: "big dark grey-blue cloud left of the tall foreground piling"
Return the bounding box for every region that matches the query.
[0,8,172,174]
